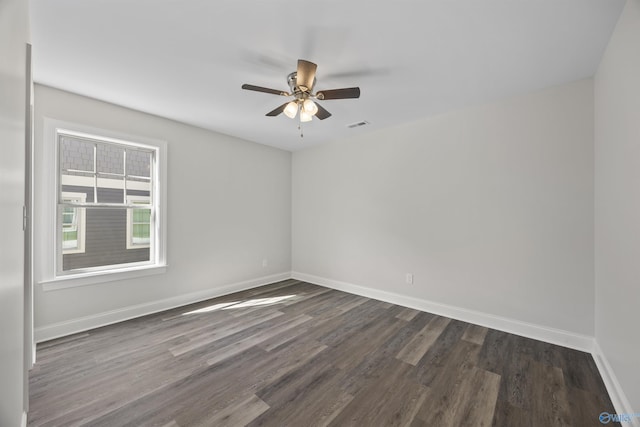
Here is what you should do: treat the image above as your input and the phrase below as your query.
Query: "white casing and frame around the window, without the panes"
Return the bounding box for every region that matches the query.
[36,118,167,291]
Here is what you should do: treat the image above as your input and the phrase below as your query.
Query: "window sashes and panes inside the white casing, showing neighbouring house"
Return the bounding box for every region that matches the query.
[58,131,156,273]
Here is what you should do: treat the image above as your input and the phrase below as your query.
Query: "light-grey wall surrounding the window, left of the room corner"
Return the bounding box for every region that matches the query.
[35,85,291,339]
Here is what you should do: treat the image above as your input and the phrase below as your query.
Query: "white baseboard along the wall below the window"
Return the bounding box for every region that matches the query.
[34,272,291,342]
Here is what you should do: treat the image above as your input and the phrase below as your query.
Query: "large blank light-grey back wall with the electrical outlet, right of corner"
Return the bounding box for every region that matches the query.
[292,80,594,336]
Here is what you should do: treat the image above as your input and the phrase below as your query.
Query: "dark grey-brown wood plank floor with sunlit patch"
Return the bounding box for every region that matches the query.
[29,280,615,427]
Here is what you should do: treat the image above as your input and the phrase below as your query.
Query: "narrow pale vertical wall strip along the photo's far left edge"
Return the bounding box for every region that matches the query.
[0,0,29,427]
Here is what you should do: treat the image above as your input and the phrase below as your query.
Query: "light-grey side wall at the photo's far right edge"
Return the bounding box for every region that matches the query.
[594,0,640,414]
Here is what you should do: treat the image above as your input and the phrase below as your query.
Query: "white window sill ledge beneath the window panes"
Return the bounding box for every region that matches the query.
[38,264,167,292]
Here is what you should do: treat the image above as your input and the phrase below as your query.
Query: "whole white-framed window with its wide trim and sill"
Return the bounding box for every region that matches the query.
[39,119,166,290]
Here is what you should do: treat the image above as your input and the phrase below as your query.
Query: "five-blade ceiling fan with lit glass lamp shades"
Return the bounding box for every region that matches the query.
[242,59,360,123]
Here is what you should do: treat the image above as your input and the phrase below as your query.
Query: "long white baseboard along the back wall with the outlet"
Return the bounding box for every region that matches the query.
[291,271,594,353]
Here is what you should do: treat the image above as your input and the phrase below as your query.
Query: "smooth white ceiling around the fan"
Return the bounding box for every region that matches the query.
[31,0,624,150]
